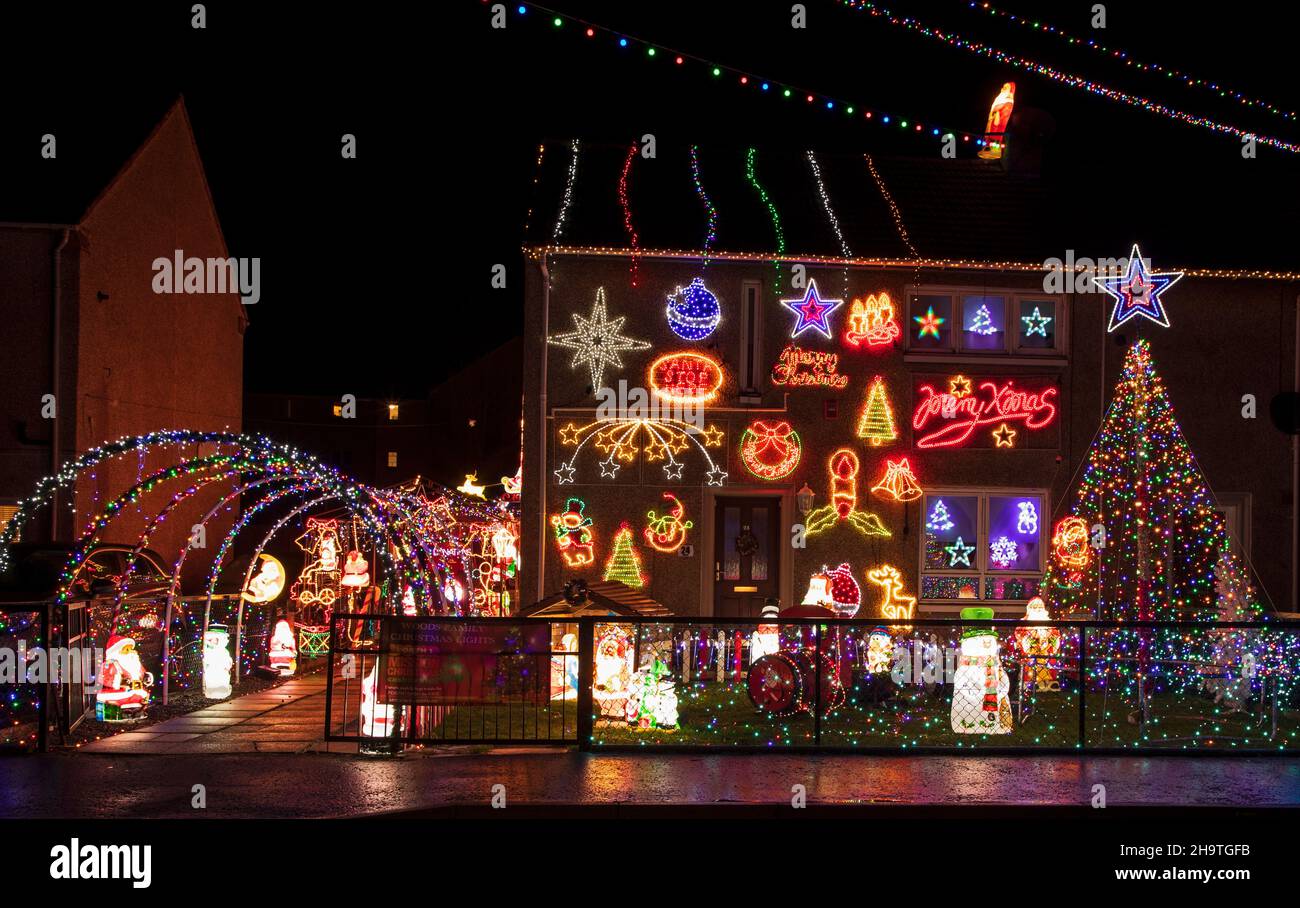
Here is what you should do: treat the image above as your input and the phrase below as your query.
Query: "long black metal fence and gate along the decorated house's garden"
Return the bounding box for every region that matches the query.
[326,615,1300,753]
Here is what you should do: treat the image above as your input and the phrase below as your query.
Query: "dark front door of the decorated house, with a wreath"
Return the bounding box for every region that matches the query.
[714,497,781,618]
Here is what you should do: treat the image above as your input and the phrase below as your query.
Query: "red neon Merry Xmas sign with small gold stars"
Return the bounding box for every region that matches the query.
[911,376,1057,447]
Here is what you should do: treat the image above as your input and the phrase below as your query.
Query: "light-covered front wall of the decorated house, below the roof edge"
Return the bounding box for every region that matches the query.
[521,255,1296,619]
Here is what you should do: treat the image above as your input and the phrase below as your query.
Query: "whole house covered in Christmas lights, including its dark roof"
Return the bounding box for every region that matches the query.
[520,143,1300,619]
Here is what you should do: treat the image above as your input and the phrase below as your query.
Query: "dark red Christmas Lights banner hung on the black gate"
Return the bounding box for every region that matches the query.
[377,621,551,705]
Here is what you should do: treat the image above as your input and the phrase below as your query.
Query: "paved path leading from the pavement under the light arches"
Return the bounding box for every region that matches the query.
[79,673,356,754]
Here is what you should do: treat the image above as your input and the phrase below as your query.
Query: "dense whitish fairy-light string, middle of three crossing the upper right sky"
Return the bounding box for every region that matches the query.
[841,0,1300,154]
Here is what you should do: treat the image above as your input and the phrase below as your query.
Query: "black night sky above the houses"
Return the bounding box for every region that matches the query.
[0,0,1300,395]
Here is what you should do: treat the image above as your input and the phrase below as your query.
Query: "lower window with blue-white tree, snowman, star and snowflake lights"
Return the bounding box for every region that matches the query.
[920,489,1048,602]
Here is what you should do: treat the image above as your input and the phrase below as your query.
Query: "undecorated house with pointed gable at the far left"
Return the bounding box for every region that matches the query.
[0,100,247,580]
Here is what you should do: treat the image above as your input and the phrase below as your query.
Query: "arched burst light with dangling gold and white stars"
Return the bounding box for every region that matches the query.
[554,418,727,485]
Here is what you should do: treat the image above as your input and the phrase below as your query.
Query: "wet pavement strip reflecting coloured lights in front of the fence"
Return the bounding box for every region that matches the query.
[0,749,1300,818]
